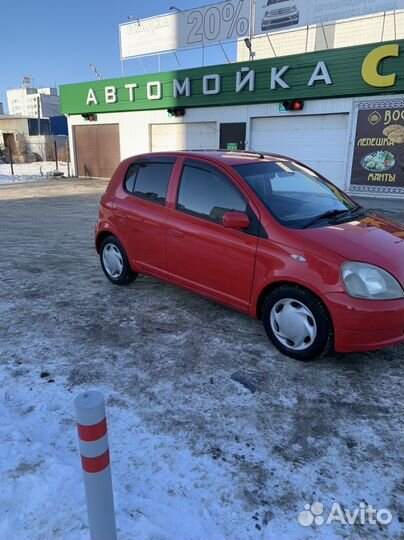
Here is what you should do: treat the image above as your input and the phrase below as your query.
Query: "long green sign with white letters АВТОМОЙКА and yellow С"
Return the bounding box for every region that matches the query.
[60,40,404,114]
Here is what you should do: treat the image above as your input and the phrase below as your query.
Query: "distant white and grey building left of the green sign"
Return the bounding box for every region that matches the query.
[7,86,60,118]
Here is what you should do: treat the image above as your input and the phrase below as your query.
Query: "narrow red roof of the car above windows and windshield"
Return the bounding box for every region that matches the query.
[133,150,290,166]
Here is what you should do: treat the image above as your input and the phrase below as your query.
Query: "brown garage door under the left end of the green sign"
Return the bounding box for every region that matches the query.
[74,124,121,178]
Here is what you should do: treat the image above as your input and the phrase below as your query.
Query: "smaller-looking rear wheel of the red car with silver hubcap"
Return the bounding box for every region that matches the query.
[100,236,137,285]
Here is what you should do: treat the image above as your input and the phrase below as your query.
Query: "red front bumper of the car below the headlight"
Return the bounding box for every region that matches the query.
[323,293,404,352]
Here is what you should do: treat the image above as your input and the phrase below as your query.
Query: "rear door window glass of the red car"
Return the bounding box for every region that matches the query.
[125,161,174,205]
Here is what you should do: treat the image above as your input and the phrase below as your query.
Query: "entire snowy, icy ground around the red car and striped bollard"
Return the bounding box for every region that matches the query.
[0,180,404,540]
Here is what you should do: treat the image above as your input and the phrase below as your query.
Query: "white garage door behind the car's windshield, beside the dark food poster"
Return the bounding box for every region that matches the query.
[251,114,348,187]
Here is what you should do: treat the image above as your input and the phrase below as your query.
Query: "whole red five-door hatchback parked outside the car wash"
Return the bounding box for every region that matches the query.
[96,151,404,360]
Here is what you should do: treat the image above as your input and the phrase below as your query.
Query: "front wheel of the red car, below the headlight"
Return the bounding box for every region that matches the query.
[262,284,333,362]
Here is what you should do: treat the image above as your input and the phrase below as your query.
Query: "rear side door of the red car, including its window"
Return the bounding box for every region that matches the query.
[114,156,175,278]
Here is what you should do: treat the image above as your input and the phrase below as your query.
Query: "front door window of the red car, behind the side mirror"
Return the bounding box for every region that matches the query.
[177,165,248,223]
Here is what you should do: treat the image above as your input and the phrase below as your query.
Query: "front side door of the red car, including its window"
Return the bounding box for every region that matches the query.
[167,159,260,310]
